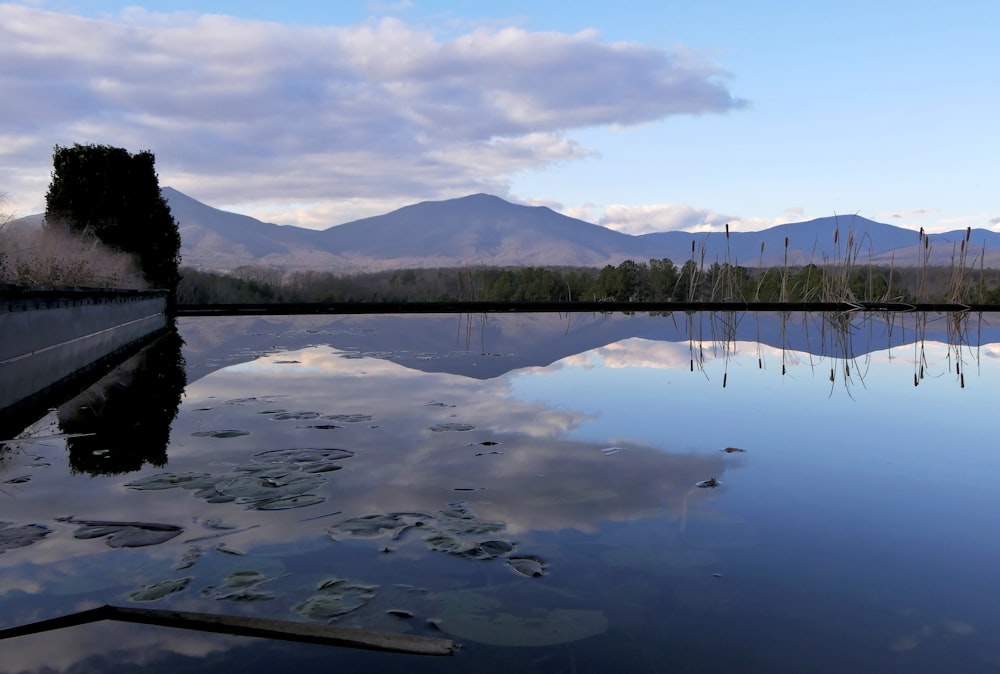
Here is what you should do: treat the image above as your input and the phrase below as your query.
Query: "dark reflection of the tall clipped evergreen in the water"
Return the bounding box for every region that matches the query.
[59,329,186,475]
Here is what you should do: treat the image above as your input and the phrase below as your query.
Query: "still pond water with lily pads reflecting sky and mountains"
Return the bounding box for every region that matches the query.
[0,314,1000,673]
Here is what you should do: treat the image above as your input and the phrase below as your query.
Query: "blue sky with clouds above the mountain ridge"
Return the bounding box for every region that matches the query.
[0,0,1000,234]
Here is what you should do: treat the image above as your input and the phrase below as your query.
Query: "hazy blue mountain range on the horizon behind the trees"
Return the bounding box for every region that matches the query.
[17,187,1000,272]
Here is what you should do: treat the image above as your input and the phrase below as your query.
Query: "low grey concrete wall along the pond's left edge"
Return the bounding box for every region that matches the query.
[0,290,167,412]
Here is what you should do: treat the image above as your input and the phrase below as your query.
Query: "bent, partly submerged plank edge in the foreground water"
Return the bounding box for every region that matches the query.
[0,606,458,655]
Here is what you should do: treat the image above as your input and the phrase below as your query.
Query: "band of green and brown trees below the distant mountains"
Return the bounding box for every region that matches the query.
[177,258,1000,304]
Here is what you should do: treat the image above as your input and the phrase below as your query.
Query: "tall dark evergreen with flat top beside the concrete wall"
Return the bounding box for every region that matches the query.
[45,144,181,291]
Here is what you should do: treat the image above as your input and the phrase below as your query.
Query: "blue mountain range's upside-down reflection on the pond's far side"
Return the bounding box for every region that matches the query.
[179,312,1000,381]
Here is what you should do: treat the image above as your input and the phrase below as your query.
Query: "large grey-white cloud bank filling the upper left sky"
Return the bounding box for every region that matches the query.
[0,4,740,225]
